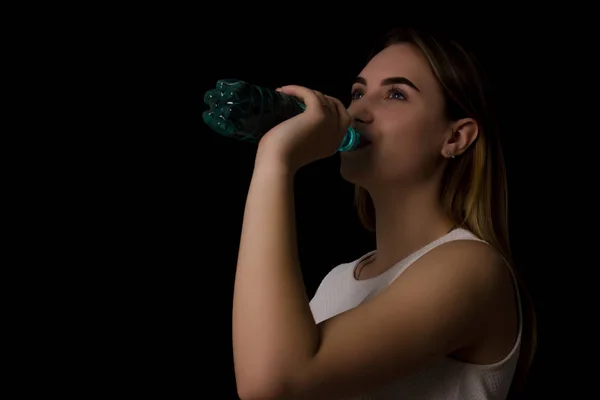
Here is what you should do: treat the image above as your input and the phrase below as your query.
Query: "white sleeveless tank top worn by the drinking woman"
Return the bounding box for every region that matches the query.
[310,228,523,400]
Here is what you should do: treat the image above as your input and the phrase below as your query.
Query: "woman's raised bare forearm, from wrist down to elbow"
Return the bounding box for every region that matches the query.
[233,159,319,398]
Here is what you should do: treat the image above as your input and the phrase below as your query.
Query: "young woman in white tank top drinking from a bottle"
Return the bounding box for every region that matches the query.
[233,29,535,400]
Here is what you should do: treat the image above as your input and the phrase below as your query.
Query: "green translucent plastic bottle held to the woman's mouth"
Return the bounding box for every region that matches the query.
[202,79,360,151]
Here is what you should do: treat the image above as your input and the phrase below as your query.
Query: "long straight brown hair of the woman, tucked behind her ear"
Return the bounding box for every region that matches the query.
[355,28,537,397]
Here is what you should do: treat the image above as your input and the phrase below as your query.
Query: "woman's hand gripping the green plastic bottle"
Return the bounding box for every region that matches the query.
[257,86,350,173]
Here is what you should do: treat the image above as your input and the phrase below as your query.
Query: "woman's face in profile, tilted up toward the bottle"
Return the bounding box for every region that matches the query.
[341,44,452,189]
